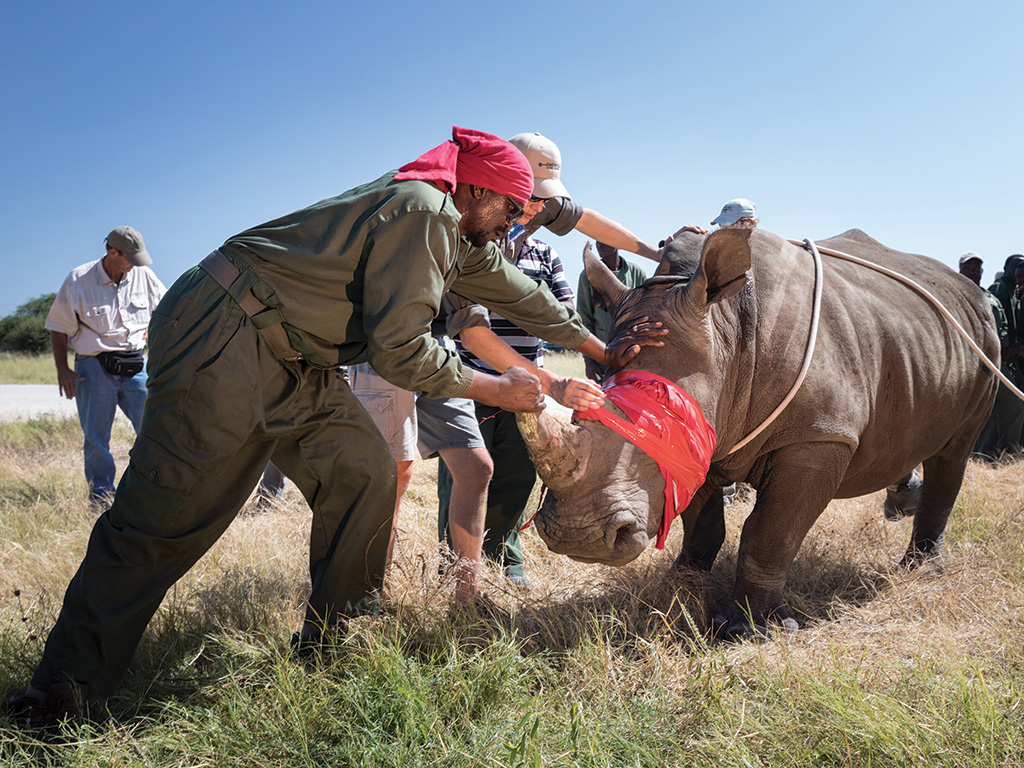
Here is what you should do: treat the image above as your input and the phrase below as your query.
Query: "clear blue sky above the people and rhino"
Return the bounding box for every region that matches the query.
[0,0,1024,315]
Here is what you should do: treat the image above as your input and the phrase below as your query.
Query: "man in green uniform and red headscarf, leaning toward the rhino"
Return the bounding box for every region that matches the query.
[8,128,618,728]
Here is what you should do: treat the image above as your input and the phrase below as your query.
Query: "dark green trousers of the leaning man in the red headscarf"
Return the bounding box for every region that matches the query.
[32,267,396,698]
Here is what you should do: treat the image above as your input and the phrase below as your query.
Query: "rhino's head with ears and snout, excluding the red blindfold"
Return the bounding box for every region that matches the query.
[520,229,752,565]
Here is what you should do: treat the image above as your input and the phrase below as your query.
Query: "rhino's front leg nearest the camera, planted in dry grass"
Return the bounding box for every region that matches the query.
[715,443,852,639]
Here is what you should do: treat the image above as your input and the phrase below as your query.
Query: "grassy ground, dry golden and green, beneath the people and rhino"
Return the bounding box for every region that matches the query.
[0,411,1024,768]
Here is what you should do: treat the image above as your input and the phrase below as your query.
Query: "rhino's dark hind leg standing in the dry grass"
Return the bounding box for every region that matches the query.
[902,440,972,567]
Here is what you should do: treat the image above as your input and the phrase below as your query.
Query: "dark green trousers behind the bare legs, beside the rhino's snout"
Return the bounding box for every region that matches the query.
[437,402,537,575]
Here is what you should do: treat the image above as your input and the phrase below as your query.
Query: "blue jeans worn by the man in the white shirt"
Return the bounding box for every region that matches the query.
[75,355,145,503]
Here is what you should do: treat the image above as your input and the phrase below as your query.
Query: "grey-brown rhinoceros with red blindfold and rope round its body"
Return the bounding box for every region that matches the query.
[520,229,999,637]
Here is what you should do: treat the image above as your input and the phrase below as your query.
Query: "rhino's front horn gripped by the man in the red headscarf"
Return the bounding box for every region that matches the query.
[516,413,591,493]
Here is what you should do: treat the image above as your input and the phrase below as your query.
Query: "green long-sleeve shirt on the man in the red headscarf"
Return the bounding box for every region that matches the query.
[227,171,588,397]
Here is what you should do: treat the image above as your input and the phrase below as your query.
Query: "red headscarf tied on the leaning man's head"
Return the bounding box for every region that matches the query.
[394,126,534,206]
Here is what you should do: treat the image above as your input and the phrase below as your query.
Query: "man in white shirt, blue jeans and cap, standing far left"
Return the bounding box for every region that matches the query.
[46,226,167,506]
